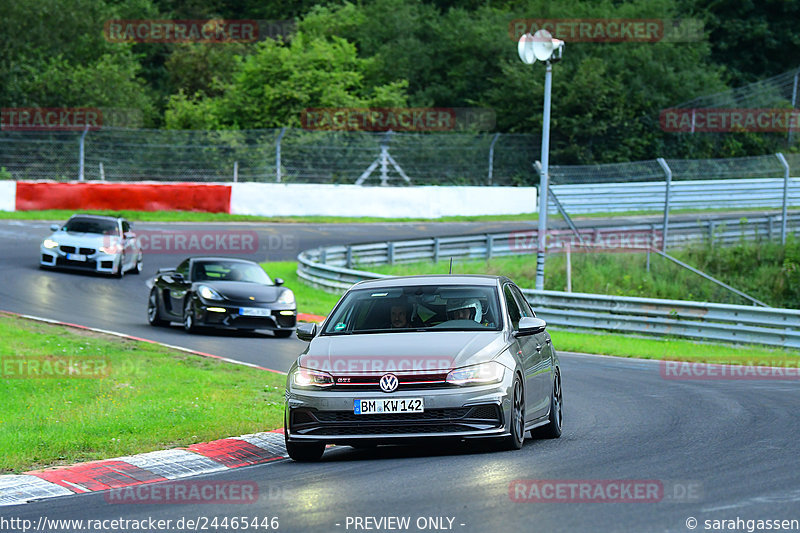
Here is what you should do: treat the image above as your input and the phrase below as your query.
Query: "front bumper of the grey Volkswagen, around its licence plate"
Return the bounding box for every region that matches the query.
[285,372,512,444]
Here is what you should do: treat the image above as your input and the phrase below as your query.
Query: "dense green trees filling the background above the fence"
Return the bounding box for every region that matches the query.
[0,0,800,164]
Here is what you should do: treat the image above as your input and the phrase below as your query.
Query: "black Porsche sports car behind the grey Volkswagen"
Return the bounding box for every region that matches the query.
[147,257,297,337]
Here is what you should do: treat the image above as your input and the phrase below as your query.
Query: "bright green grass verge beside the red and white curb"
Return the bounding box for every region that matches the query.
[0,315,285,473]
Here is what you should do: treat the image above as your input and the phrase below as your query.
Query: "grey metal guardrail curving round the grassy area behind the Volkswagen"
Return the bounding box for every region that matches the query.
[297,215,800,348]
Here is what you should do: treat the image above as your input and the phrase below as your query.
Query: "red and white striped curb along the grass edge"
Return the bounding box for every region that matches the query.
[0,430,288,506]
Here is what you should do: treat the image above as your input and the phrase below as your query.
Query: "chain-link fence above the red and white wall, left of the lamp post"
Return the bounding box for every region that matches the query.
[0,128,541,185]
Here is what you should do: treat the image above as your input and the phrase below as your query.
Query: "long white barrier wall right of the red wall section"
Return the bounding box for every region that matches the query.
[231,183,537,218]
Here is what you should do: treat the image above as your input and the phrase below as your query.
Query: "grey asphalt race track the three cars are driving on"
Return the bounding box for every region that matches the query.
[0,218,800,532]
